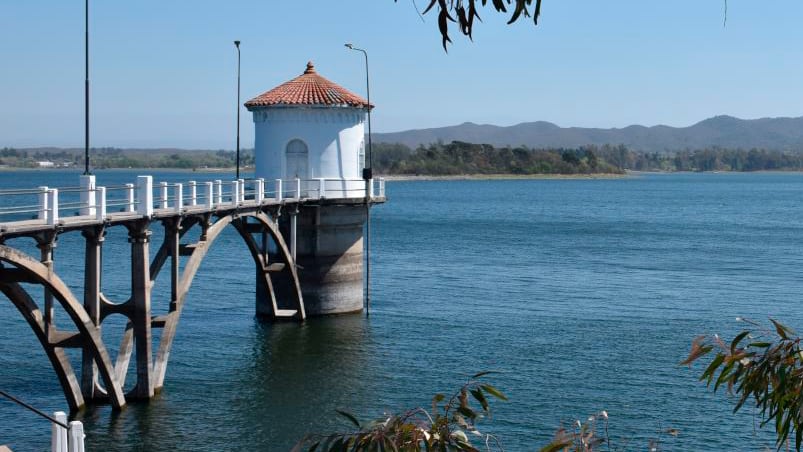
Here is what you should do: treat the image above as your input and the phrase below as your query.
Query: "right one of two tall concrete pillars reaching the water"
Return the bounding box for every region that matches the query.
[128,222,154,399]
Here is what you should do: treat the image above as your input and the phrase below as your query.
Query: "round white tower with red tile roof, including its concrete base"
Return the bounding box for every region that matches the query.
[245,62,375,315]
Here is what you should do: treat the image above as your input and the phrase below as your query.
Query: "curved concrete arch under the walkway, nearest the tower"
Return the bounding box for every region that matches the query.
[153,212,306,390]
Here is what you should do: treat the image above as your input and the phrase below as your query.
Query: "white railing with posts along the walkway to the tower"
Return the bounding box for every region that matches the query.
[0,175,385,226]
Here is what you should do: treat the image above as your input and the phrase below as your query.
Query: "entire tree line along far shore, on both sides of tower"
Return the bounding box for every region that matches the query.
[6,141,803,176]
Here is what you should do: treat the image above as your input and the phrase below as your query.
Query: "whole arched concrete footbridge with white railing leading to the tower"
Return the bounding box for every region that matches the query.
[0,176,385,410]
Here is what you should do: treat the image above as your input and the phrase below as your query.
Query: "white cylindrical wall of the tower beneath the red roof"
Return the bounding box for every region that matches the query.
[253,106,365,197]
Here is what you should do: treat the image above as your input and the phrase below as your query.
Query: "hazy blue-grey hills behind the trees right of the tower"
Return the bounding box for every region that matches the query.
[374,116,803,152]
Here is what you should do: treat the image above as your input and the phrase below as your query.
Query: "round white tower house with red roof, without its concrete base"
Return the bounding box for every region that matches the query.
[245,62,373,198]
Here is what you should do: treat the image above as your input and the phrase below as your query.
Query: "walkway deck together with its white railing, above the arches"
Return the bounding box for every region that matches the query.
[0,176,385,239]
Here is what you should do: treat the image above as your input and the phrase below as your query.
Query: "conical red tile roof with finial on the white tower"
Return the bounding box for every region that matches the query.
[245,61,373,110]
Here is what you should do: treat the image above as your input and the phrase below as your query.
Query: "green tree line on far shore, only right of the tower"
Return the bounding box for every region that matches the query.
[373,141,803,175]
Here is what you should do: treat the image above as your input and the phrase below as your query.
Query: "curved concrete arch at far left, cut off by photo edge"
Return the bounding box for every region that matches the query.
[0,245,126,410]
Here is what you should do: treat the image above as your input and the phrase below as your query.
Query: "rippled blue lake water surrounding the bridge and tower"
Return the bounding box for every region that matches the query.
[0,171,803,451]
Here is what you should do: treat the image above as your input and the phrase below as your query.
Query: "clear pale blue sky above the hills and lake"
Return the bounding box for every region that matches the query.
[0,0,803,149]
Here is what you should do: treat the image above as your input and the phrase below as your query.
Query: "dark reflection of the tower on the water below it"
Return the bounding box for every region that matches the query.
[229,315,373,450]
